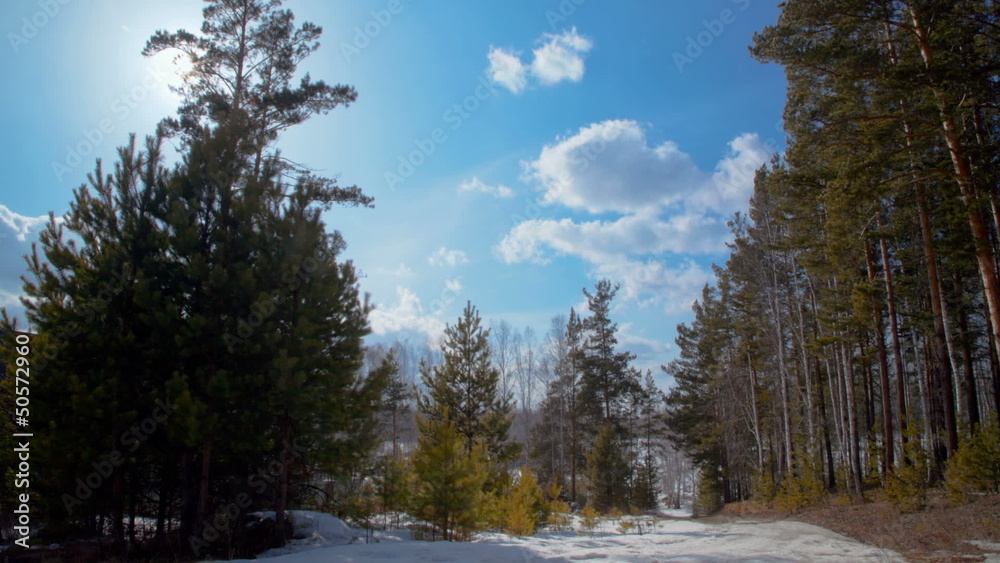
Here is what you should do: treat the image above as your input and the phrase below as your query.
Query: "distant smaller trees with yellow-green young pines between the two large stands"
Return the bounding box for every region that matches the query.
[354,280,683,540]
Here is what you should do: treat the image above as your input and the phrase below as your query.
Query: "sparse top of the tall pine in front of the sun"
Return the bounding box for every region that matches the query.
[142,0,360,185]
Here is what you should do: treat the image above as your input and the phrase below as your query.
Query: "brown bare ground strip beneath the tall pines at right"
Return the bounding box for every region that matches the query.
[705,491,1000,561]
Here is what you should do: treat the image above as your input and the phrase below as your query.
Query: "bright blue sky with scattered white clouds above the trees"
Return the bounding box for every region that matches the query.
[0,0,786,385]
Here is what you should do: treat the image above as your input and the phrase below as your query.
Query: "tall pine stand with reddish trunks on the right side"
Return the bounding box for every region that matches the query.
[667,0,1000,510]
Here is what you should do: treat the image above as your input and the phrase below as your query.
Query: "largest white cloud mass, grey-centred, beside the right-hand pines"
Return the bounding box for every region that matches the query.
[494,120,772,313]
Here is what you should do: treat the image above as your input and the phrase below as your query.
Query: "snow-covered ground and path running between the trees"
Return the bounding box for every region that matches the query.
[229,512,904,563]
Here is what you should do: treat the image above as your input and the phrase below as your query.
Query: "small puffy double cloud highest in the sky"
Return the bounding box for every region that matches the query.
[486,27,594,94]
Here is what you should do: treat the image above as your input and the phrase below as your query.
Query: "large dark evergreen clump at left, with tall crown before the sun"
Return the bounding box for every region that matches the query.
[0,1,380,554]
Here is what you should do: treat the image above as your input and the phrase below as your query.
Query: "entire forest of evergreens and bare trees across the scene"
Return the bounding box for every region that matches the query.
[0,0,1000,560]
